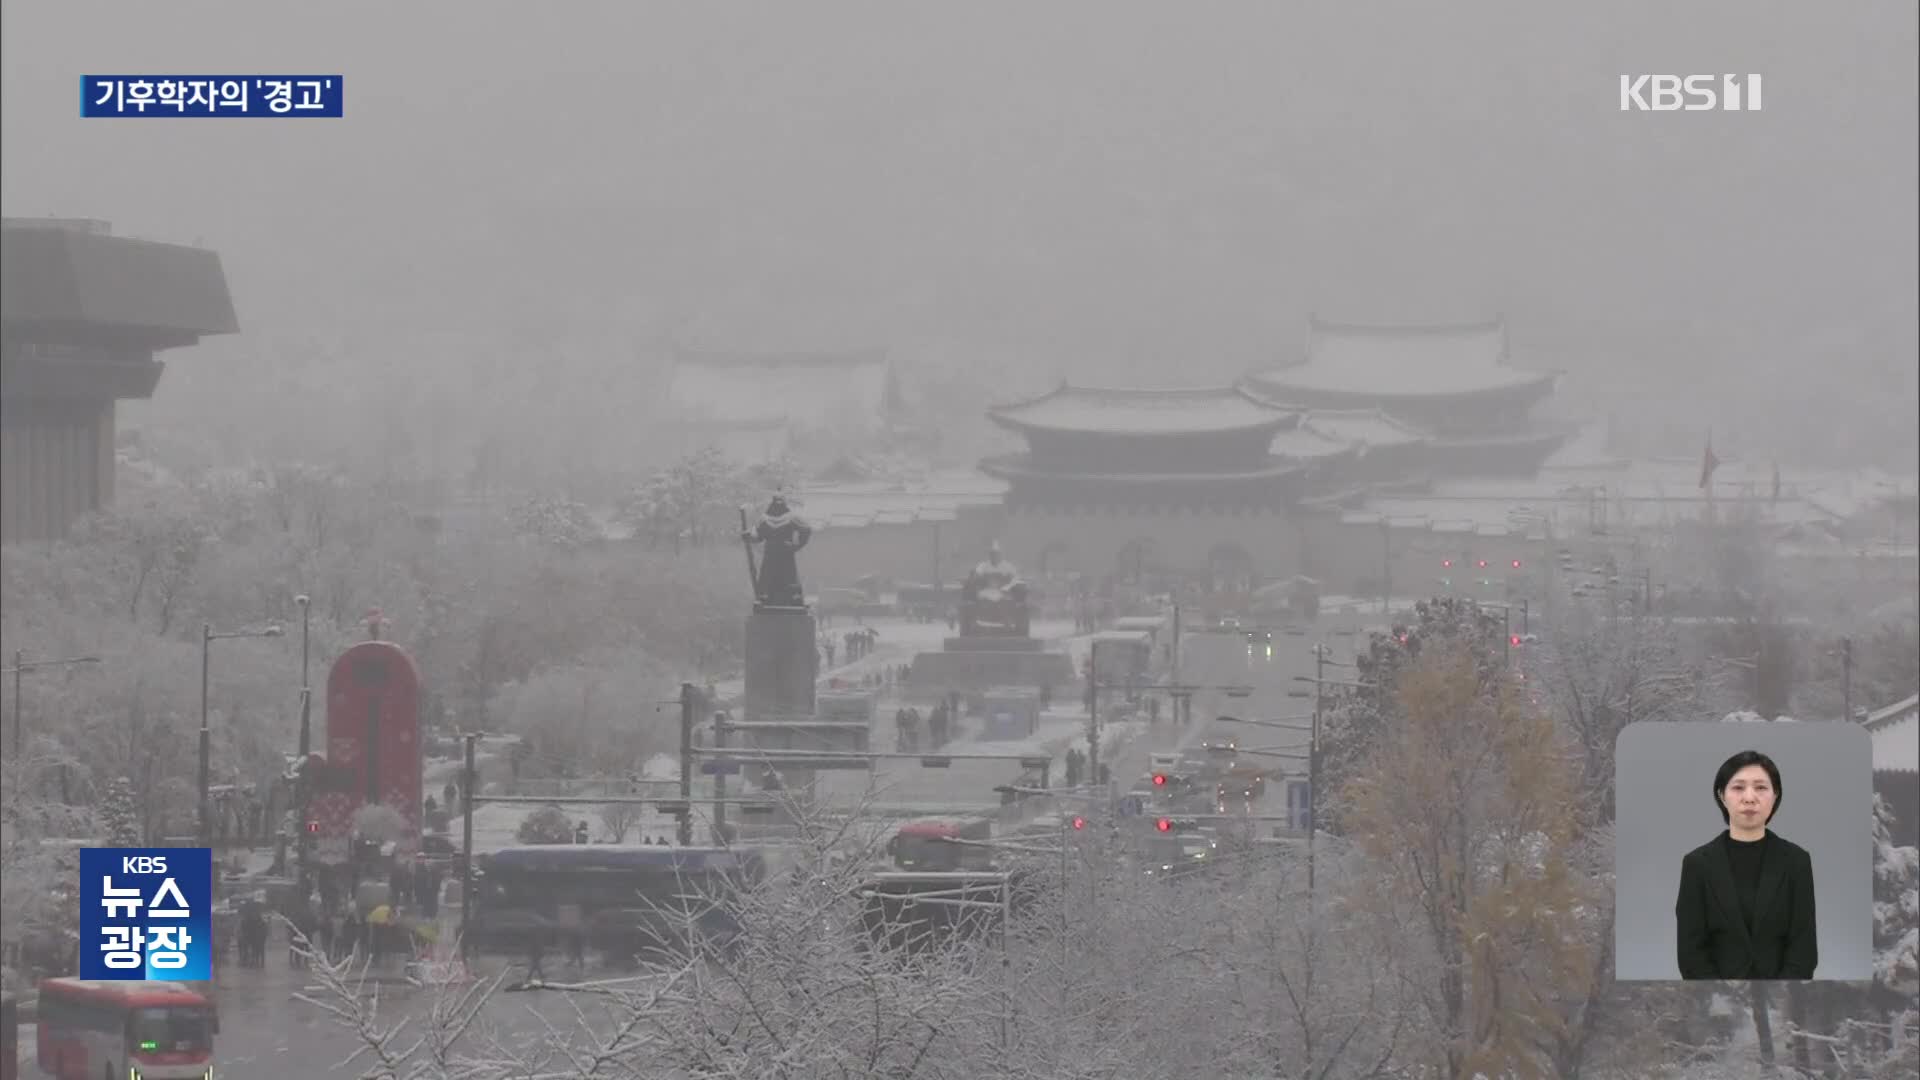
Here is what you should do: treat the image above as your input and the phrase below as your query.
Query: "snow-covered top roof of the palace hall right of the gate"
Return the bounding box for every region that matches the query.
[1252,319,1557,398]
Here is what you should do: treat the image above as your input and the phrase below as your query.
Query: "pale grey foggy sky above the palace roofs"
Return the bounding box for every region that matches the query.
[0,0,1920,463]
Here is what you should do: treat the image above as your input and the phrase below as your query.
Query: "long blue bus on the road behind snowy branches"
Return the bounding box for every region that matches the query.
[467,844,766,957]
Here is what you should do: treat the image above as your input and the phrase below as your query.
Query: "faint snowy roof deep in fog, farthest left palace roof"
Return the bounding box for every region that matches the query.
[668,348,897,429]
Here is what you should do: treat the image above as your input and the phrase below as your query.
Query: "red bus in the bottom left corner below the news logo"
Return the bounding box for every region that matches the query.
[36,978,221,1080]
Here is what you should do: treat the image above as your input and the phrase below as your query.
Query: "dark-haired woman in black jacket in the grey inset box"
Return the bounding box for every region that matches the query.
[1674,749,1820,978]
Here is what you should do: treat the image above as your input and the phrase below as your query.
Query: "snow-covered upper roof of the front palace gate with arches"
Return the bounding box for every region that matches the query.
[987,382,1298,434]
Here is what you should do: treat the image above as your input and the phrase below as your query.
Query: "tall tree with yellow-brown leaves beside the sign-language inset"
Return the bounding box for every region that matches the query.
[1344,640,1592,1080]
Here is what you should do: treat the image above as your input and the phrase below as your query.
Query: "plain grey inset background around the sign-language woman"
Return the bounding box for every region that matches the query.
[1613,723,1874,982]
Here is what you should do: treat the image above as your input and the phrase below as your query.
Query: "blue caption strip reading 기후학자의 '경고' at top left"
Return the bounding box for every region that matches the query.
[81,75,346,119]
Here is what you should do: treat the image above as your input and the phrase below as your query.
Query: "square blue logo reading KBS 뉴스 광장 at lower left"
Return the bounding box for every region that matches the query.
[81,847,213,982]
